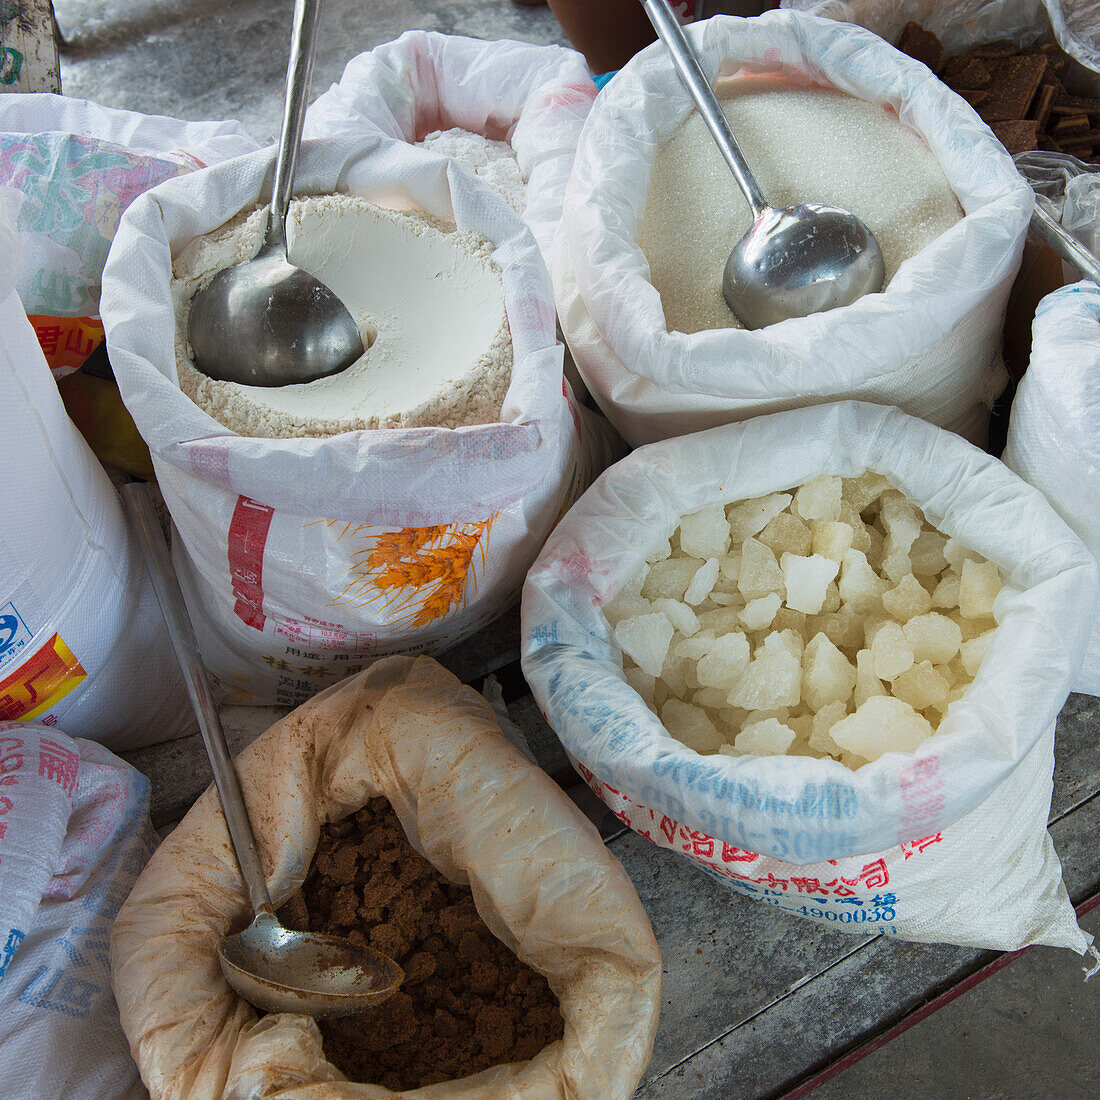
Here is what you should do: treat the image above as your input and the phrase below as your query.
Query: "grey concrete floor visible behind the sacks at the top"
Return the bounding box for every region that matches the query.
[54,0,568,144]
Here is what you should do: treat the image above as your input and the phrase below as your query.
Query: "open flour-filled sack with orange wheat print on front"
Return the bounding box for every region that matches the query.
[103,136,603,705]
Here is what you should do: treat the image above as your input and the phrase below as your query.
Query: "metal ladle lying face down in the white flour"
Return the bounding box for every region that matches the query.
[187,0,364,386]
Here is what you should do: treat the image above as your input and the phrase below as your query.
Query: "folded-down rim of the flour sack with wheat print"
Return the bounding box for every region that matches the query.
[101,135,570,521]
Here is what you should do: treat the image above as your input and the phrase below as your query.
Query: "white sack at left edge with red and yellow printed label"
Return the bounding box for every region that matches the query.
[0,190,194,749]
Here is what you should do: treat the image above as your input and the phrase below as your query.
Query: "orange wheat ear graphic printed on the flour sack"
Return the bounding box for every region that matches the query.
[307,514,496,628]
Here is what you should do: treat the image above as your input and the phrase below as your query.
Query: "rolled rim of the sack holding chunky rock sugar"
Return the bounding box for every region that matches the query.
[521,402,1100,864]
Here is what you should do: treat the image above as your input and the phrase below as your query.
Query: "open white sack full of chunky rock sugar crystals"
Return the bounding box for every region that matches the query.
[523,402,1098,953]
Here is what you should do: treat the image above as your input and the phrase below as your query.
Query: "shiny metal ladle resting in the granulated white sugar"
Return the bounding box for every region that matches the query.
[641,0,886,329]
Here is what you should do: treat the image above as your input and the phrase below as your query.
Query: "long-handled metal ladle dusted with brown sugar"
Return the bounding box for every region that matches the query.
[122,482,405,1016]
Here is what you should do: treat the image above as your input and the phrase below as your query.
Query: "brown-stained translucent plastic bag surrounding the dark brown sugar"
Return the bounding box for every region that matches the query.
[111,658,661,1100]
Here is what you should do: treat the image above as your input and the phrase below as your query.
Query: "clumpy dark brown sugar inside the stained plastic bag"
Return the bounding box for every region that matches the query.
[281,799,563,1091]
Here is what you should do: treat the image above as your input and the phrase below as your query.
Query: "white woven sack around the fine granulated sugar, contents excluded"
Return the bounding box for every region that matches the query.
[553,12,1033,446]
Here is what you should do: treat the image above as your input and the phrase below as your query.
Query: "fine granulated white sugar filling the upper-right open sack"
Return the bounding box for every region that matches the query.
[639,77,963,332]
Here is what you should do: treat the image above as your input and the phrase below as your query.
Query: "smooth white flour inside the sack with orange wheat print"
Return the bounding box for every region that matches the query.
[172,195,512,438]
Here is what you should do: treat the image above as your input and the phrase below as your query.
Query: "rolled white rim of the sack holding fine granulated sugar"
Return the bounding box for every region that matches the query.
[559,11,1034,400]
